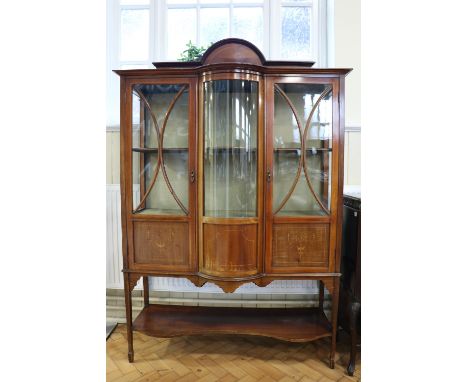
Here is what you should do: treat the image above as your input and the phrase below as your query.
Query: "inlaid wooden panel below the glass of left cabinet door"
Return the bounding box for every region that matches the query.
[133,221,190,271]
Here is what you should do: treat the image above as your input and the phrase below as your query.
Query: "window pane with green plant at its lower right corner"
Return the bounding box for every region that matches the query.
[167,8,197,60]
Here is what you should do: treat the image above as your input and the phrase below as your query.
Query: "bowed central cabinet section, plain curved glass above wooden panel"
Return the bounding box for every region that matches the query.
[198,74,263,278]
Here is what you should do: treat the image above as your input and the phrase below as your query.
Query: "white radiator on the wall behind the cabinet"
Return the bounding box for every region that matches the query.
[106,184,318,294]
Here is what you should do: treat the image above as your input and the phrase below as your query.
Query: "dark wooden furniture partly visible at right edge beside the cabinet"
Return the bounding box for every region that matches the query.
[338,195,361,375]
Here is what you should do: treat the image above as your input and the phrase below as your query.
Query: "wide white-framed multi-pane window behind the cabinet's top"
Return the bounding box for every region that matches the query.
[107,0,331,126]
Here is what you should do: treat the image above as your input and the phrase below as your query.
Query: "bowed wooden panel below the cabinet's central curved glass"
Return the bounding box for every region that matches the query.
[203,224,258,276]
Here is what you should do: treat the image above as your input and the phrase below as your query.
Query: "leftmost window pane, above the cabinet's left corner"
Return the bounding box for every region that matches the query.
[120,9,149,61]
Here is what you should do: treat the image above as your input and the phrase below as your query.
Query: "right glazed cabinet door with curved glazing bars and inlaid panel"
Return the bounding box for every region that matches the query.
[265,77,339,273]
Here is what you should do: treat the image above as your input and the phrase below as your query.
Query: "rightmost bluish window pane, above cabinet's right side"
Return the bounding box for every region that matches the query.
[281,7,312,60]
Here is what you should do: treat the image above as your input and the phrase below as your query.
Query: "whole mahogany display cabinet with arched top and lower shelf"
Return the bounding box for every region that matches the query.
[115,39,350,368]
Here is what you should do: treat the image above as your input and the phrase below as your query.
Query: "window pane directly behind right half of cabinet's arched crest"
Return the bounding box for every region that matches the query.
[232,7,263,50]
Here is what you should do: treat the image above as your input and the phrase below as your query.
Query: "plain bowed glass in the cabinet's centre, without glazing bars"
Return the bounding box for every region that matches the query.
[203,80,258,217]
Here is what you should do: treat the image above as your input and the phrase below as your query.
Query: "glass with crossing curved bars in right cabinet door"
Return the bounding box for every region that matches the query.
[273,83,332,216]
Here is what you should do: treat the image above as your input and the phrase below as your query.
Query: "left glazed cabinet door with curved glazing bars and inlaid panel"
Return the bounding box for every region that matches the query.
[124,78,197,273]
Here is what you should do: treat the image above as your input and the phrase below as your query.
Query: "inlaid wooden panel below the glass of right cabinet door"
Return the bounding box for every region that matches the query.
[272,223,329,270]
